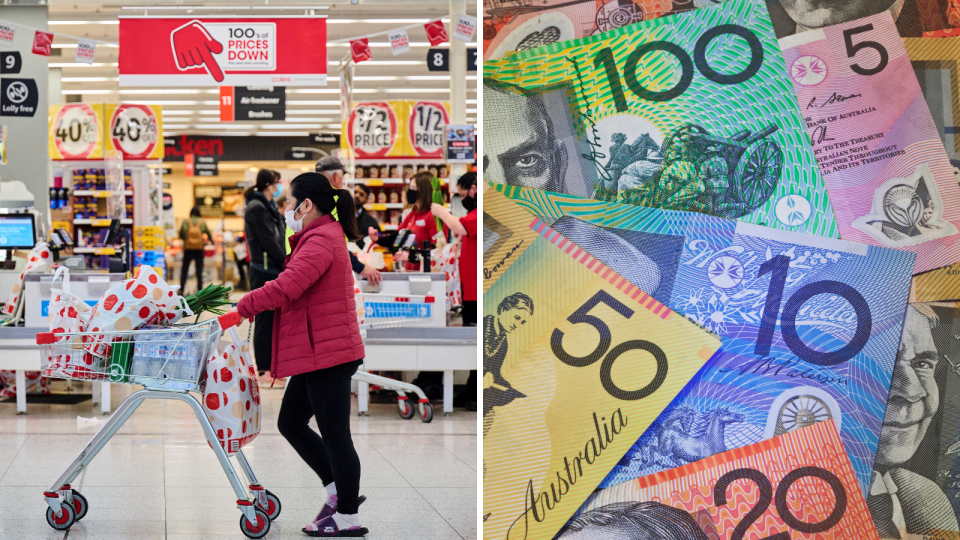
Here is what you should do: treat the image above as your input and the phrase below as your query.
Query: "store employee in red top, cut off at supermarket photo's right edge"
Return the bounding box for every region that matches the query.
[430,172,478,326]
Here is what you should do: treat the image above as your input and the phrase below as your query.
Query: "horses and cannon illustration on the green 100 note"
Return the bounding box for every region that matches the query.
[597,124,783,219]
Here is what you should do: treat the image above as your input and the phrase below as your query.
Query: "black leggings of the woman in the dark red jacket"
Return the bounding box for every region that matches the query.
[277,360,362,514]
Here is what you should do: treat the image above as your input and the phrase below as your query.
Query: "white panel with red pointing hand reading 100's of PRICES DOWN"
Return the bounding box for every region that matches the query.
[170,20,277,82]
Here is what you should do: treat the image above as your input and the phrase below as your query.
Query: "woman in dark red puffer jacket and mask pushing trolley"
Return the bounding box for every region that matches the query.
[237,173,367,537]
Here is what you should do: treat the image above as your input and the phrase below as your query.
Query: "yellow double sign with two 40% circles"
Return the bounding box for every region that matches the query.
[49,103,164,160]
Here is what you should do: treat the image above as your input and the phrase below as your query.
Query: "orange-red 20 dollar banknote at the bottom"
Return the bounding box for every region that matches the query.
[572,421,880,540]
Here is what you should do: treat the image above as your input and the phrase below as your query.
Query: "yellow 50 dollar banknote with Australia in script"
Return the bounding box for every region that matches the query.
[483,221,720,539]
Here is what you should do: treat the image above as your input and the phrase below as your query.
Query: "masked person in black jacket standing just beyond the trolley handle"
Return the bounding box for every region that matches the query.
[243,169,287,383]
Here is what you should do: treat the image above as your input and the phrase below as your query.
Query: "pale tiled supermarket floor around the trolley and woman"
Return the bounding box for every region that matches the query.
[0,378,477,540]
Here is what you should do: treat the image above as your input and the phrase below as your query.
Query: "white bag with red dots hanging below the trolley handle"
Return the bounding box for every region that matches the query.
[203,328,260,454]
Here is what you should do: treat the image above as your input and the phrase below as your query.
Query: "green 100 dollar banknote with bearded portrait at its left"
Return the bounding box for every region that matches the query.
[483,0,839,238]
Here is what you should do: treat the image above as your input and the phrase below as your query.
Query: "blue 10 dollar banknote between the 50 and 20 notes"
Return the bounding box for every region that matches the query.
[502,184,914,493]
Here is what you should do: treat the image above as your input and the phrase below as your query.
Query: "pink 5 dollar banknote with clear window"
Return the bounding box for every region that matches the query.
[780,12,960,273]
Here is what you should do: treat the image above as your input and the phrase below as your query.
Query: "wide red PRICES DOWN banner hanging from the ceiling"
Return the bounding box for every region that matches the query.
[120,17,327,86]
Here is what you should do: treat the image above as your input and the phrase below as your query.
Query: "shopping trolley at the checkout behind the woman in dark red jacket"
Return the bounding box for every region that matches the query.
[353,293,436,423]
